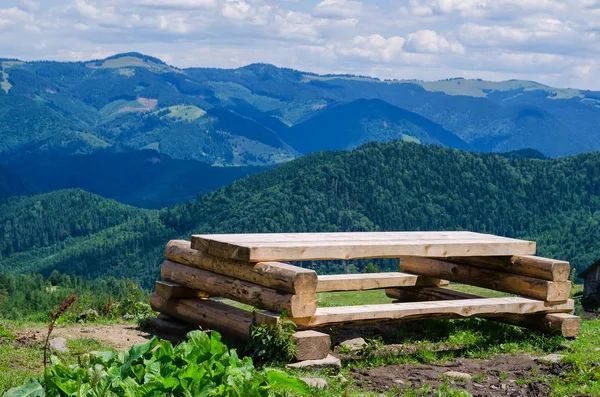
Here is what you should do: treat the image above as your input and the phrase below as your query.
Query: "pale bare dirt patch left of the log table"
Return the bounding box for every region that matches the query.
[17,324,152,350]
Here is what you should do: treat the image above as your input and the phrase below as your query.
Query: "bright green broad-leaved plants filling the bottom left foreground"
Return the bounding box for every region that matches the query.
[6,331,308,397]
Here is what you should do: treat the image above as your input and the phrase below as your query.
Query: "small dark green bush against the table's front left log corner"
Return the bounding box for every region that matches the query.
[247,312,297,364]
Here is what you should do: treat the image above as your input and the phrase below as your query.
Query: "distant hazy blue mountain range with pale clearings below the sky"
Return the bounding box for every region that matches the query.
[0,53,600,166]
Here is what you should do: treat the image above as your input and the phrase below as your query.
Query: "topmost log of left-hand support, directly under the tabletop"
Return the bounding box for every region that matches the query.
[165,240,317,294]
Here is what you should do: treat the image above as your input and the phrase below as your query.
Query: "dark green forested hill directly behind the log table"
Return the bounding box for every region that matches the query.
[0,141,600,286]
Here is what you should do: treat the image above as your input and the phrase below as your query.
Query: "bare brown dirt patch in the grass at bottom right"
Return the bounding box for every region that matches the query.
[353,355,568,397]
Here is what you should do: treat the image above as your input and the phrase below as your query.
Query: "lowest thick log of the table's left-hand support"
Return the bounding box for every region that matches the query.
[150,294,252,340]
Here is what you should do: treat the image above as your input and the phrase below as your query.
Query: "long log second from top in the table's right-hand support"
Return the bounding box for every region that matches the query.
[400,257,571,302]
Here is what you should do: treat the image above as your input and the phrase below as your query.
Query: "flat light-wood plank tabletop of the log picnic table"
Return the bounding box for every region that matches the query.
[192,232,535,262]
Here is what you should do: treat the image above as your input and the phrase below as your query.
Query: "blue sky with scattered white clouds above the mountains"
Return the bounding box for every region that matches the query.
[0,0,600,89]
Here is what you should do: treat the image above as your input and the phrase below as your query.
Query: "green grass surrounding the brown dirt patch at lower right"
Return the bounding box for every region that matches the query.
[286,319,600,397]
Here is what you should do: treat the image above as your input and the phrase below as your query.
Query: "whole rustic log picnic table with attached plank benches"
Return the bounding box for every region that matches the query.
[151,232,581,359]
